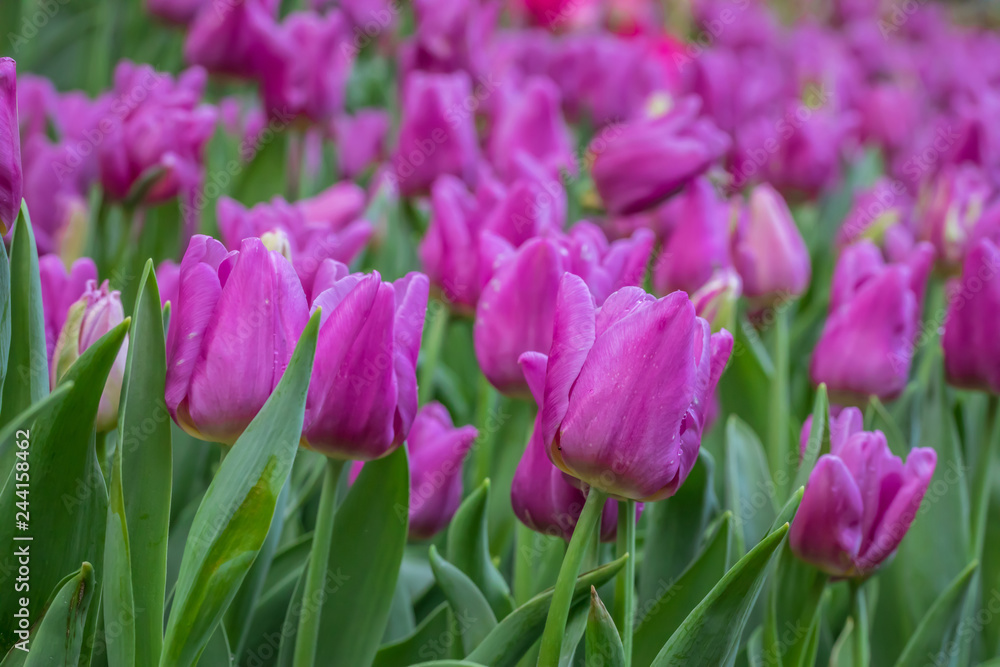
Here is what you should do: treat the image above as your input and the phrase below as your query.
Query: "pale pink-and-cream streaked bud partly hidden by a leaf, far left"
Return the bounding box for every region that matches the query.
[49,280,128,433]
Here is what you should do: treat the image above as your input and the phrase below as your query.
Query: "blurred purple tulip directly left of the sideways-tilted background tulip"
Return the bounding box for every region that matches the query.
[488,77,576,179]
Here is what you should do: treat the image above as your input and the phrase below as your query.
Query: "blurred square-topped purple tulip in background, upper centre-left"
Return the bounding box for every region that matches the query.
[393,72,479,195]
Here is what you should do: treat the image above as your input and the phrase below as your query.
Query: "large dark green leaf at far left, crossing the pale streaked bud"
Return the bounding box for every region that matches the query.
[0,320,129,651]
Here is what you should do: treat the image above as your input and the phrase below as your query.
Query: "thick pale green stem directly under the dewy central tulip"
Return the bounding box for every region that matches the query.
[538,487,608,667]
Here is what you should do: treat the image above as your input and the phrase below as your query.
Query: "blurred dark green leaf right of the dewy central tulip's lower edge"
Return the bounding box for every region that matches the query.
[637,449,721,609]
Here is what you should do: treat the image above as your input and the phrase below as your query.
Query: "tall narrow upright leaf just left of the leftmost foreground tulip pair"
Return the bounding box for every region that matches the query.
[113,262,172,667]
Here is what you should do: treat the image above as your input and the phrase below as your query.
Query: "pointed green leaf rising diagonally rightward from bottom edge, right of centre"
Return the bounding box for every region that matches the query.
[653,524,788,667]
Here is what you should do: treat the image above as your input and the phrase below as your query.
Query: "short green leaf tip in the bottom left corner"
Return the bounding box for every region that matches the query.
[24,562,95,667]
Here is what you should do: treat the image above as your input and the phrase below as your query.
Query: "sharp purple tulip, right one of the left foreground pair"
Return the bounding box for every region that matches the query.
[303,260,429,461]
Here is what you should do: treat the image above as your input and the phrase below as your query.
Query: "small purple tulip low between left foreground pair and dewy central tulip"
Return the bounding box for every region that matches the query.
[351,402,479,540]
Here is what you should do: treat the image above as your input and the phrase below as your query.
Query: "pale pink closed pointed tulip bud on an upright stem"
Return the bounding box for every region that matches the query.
[733,183,812,306]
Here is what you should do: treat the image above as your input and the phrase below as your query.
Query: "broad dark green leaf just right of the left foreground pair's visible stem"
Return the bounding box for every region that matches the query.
[316,447,410,665]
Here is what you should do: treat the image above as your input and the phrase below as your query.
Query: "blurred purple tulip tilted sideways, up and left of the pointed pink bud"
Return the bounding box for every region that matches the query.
[591,98,729,215]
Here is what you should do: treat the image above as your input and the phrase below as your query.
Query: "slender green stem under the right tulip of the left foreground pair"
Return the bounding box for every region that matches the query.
[292,459,345,667]
